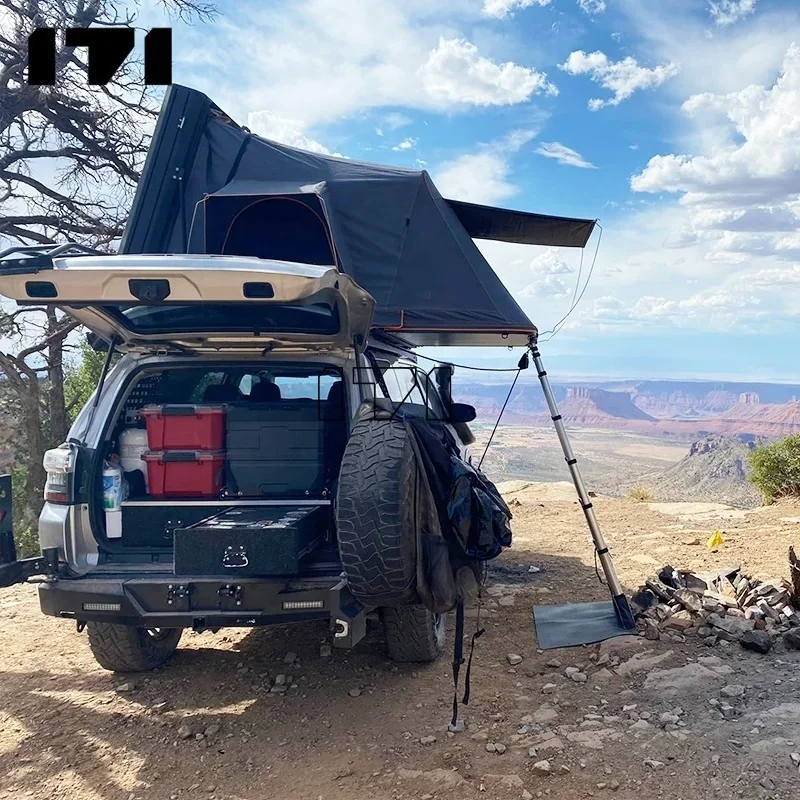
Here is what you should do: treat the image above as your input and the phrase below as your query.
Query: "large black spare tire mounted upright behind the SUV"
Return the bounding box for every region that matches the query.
[336,418,419,606]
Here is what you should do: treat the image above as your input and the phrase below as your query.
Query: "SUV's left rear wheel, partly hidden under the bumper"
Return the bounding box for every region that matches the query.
[86,622,183,672]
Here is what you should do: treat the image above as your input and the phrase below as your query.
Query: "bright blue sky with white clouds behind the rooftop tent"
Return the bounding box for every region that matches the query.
[155,0,800,380]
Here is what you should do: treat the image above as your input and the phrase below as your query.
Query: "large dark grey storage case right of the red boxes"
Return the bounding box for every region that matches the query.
[226,401,325,499]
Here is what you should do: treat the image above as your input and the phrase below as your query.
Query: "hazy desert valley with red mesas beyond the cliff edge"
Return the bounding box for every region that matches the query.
[455,375,800,508]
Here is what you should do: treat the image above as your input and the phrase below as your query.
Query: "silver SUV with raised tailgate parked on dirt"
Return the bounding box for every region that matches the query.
[0,248,474,671]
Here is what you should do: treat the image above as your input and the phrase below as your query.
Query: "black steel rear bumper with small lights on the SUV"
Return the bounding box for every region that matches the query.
[39,576,367,647]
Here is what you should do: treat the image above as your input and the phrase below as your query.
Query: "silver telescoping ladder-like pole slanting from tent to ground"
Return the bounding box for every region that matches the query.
[530,338,636,628]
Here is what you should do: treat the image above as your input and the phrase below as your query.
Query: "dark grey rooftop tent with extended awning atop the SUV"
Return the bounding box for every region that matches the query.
[121,86,594,345]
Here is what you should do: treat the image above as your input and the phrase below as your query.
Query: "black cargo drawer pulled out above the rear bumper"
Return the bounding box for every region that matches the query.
[175,506,330,580]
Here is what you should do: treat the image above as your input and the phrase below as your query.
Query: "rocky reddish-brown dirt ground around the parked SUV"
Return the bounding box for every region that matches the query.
[0,484,800,800]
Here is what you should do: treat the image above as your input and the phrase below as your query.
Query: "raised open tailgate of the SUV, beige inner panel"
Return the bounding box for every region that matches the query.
[0,255,375,351]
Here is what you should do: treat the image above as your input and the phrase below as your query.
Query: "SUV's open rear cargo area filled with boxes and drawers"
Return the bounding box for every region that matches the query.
[93,362,349,578]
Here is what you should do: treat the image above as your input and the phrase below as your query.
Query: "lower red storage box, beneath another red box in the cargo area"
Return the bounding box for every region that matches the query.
[142,450,225,498]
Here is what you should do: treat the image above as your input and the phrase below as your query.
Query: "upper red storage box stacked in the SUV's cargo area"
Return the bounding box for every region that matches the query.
[142,404,225,452]
